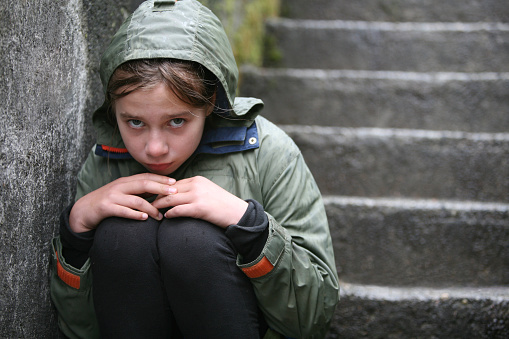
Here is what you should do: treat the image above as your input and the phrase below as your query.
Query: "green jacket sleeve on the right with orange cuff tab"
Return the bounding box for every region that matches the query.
[238,123,339,338]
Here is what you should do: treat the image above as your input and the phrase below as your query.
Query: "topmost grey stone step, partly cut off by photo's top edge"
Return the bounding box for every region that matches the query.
[281,0,509,22]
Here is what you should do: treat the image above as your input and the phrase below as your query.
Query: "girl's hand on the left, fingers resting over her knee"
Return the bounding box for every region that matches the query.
[69,173,176,233]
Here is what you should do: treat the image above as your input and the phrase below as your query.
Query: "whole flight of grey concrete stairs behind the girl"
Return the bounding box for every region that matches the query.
[240,0,509,338]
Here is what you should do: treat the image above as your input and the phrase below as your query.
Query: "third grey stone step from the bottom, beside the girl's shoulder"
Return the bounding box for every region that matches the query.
[282,125,509,202]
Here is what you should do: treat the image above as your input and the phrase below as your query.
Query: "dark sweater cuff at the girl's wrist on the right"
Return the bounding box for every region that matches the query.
[225,200,269,263]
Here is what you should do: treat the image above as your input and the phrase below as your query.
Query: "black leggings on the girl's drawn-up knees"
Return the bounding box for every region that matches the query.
[90,218,267,339]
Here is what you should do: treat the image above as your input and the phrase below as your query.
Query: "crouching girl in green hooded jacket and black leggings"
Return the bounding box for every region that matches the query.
[51,0,338,339]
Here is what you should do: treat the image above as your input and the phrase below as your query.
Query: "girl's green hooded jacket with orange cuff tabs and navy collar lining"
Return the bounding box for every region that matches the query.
[51,0,339,339]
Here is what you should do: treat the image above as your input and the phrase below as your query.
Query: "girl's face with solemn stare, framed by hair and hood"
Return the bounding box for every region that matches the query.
[115,83,213,175]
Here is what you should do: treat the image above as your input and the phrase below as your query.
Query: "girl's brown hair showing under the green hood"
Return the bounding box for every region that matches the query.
[107,59,219,108]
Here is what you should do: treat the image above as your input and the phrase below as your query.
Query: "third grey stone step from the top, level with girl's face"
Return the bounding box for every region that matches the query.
[240,66,509,132]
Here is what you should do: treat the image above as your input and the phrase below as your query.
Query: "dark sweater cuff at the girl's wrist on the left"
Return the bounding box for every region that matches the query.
[60,205,95,269]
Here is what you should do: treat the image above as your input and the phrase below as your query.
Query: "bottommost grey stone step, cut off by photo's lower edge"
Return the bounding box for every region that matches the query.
[327,284,509,339]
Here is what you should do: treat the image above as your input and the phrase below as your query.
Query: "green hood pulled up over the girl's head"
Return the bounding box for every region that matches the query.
[93,0,263,148]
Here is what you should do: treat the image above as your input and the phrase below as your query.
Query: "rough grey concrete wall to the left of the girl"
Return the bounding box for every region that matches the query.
[0,0,140,338]
